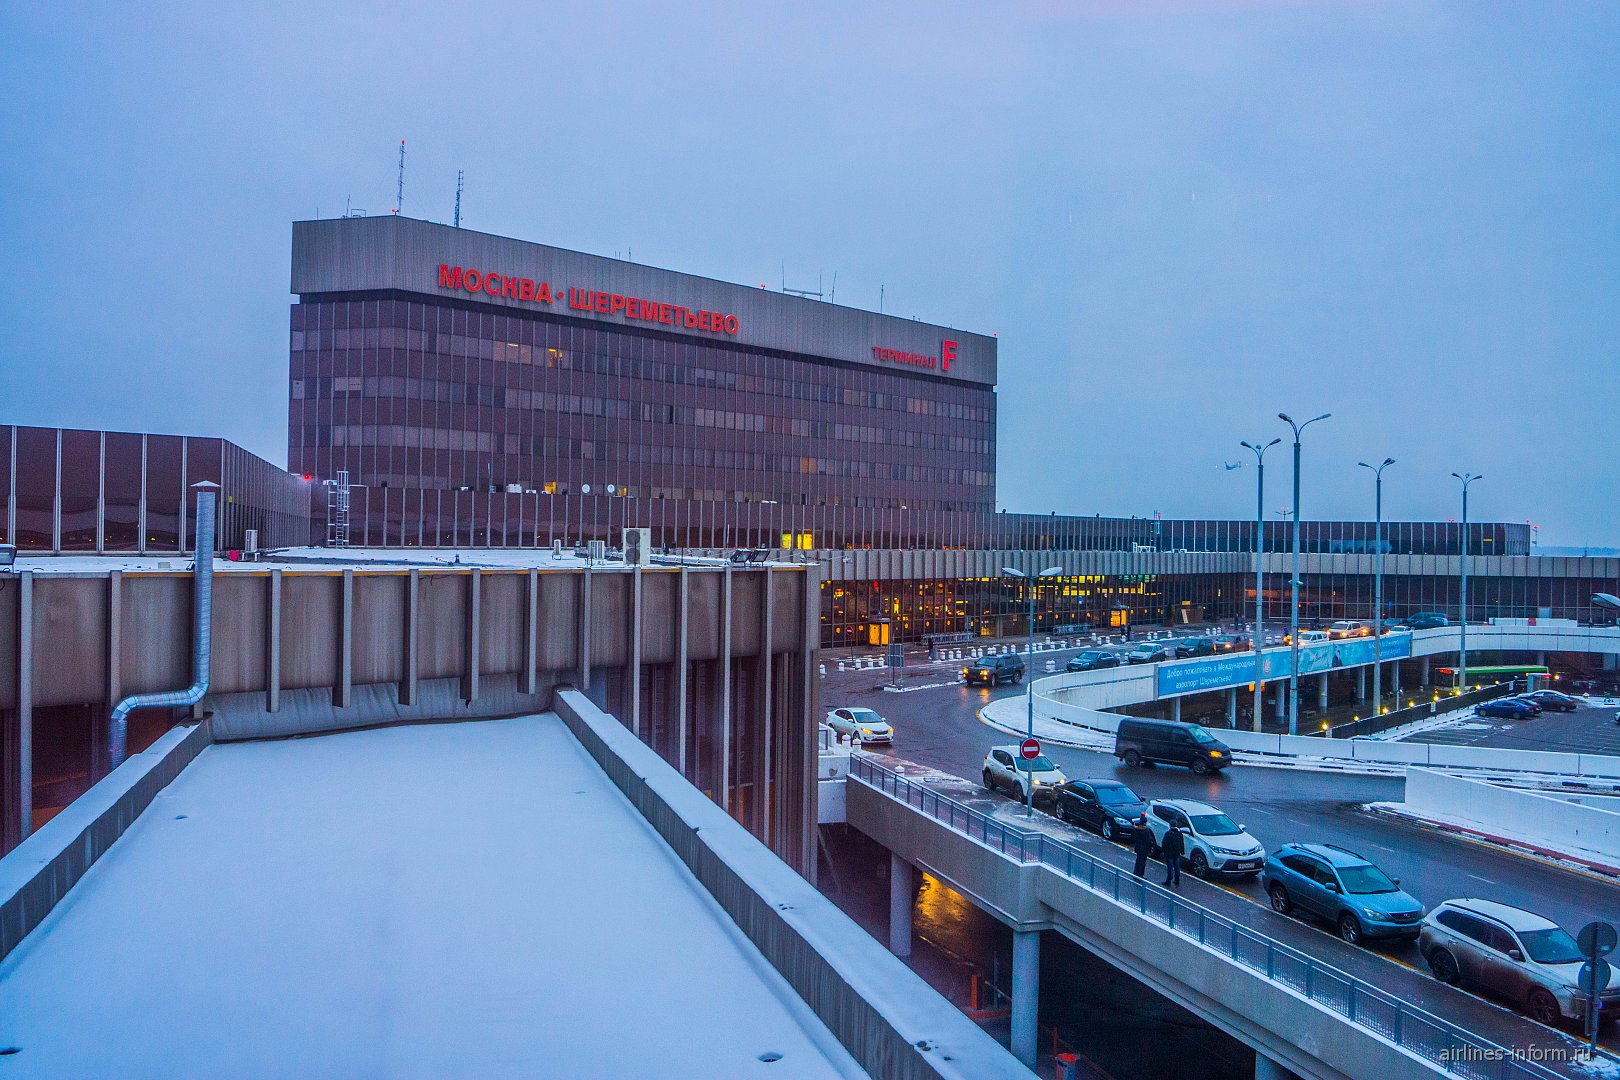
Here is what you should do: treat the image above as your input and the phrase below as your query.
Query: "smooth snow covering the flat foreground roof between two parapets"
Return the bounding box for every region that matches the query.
[0,716,863,1080]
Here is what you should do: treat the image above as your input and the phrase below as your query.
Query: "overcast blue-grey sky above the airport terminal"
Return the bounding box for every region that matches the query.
[0,0,1620,546]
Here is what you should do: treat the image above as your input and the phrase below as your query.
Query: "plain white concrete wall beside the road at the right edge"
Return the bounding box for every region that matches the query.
[1406,769,1620,866]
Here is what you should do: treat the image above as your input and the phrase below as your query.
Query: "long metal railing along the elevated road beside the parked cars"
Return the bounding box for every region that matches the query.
[849,753,1558,1080]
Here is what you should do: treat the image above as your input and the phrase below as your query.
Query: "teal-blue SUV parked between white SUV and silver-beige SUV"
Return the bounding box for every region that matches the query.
[1260,844,1422,944]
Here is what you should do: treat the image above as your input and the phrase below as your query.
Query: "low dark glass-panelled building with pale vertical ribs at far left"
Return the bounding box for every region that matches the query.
[0,427,311,552]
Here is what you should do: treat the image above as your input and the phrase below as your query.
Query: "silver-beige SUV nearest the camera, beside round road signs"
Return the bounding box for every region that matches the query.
[1418,899,1620,1025]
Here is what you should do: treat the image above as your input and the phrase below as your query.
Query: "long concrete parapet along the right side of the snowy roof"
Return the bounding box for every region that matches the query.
[556,690,1030,1080]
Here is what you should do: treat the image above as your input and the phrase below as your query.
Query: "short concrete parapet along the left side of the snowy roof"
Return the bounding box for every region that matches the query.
[0,722,212,960]
